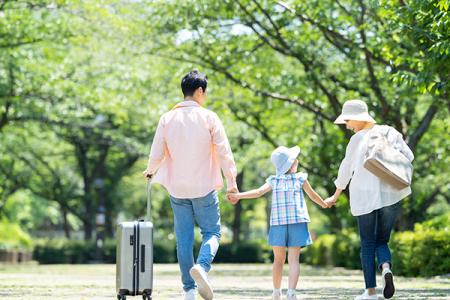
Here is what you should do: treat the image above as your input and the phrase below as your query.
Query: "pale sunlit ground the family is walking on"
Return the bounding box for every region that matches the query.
[0,264,450,300]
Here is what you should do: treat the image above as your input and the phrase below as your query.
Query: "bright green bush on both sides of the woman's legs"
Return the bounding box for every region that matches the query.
[302,214,450,276]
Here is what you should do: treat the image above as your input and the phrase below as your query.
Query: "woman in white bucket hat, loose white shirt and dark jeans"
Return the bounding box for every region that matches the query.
[326,100,414,300]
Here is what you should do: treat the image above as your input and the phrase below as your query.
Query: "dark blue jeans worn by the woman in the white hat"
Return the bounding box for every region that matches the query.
[357,202,400,288]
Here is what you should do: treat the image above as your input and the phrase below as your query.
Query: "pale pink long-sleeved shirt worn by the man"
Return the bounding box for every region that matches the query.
[147,101,237,198]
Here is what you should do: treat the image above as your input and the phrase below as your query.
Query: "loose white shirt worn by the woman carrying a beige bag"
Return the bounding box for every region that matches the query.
[334,125,414,216]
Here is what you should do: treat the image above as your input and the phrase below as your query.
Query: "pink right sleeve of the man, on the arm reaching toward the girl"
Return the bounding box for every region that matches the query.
[211,114,238,192]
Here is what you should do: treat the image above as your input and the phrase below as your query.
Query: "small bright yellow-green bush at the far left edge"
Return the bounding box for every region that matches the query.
[0,220,33,251]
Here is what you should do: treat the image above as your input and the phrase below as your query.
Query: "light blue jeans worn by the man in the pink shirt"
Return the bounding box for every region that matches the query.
[170,191,220,291]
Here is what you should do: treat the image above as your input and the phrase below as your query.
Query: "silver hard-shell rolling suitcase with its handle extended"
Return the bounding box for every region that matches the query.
[116,180,153,300]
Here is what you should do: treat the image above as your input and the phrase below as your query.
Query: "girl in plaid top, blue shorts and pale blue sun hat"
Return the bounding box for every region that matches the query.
[228,146,327,300]
